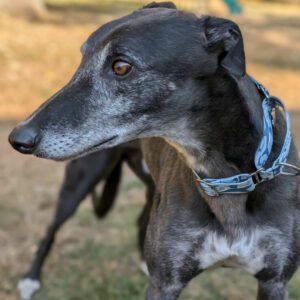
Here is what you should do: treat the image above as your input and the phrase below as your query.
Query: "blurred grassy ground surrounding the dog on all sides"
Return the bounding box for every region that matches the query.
[0,0,300,300]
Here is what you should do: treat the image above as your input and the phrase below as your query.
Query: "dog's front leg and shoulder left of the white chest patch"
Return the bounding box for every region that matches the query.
[145,194,201,300]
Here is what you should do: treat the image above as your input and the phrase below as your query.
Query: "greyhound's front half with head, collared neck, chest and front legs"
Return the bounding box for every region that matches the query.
[9,3,300,300]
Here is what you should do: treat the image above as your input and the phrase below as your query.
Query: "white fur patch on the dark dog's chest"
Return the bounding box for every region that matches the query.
[191,229,287,274]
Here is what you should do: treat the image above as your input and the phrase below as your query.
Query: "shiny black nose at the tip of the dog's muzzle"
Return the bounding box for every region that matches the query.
[8,126,39,154]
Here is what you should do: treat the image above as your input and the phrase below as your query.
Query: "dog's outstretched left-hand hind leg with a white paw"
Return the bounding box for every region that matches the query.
[18,150,120,300]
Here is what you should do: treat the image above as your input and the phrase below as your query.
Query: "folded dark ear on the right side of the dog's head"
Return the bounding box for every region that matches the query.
[203,17,246,78]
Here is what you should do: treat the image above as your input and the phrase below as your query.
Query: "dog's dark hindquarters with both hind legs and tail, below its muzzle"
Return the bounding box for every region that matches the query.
[18,142,154,300]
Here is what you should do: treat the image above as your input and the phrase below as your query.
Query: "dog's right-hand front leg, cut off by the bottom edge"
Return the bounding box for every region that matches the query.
[257,280,288,300]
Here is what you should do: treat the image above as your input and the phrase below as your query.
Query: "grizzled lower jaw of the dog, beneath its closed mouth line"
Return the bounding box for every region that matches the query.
[34,135,120,161]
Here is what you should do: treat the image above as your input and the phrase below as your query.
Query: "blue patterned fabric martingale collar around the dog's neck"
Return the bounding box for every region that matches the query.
[193,78,300,196]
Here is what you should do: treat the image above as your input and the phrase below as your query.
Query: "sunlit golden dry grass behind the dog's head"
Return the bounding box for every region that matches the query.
[0,1,300,120]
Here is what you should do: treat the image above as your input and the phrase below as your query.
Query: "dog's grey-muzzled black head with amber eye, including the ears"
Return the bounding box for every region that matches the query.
[9,2,245,160]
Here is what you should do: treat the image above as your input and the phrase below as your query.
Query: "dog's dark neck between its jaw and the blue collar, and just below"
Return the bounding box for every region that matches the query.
[168,75,263,230]
